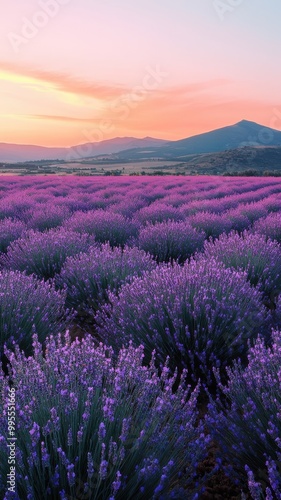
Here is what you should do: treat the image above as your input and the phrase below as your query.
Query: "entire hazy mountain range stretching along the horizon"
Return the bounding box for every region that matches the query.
[0,120,281,163]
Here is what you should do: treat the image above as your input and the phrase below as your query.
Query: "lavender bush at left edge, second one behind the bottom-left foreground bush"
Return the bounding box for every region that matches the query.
[1,228,94,279]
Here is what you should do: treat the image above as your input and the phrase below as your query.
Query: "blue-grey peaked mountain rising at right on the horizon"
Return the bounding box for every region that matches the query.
[107,120,281,160]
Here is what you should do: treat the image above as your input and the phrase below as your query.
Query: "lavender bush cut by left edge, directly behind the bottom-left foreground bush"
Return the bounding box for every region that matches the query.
[0,270,65,355]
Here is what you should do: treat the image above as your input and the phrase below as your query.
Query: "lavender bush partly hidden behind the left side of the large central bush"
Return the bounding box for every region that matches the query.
[57,244,156,311]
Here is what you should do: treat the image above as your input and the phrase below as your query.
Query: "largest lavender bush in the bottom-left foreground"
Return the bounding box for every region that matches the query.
[0,335,209,500]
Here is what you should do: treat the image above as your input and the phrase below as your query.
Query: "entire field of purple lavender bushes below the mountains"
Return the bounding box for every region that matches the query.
[0,176,281,500]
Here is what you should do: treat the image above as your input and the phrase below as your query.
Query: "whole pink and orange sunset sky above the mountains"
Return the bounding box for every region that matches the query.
[0,0,281,146]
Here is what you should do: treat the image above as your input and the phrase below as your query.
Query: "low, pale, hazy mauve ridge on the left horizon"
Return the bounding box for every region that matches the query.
[0,137,166,162]
